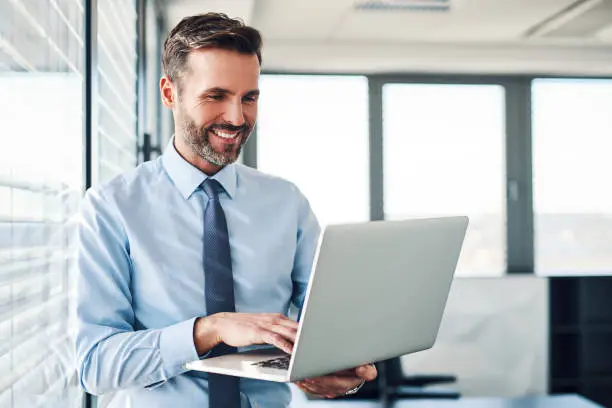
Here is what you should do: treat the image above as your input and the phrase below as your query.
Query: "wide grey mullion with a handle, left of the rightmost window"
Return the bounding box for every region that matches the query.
[505,78,534,274]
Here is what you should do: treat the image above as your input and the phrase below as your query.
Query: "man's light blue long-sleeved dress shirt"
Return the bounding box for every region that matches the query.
[76,141,320,408]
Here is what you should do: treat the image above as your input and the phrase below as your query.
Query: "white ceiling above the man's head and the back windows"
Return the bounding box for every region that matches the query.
[166,0,612,74]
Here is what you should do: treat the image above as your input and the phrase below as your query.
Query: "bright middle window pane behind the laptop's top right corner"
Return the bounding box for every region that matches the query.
[383,84,506,276]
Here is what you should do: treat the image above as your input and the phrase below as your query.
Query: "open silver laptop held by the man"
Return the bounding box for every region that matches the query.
[185,217,468,382]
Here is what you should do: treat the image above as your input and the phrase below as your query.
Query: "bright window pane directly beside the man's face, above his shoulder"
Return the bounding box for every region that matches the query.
[257,75,370,225]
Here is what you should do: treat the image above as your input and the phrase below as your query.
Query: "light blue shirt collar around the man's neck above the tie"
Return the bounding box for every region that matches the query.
[162,136,236,199]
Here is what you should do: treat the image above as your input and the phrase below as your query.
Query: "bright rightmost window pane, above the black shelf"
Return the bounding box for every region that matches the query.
[532,79,612,275]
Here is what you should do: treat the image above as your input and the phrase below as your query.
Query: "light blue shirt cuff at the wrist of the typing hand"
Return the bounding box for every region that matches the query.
[159,317,199,380]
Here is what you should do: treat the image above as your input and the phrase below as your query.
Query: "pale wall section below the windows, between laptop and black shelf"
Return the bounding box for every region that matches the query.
[402,276,548,397]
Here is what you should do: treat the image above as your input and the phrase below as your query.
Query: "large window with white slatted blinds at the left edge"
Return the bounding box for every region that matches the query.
[0,1,83,408]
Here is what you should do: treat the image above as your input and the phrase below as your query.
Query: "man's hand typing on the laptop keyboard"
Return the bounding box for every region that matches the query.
[194,313,298,355]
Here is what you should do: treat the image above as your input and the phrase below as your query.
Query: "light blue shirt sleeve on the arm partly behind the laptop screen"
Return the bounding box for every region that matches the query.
[291,188,321,316]
